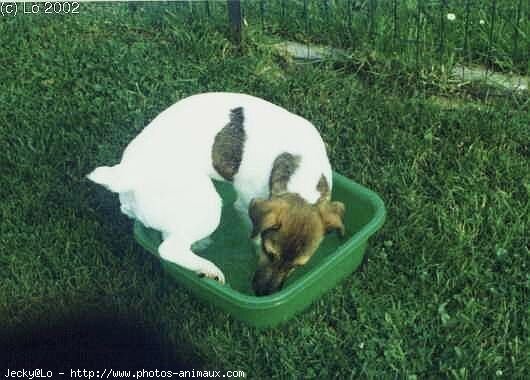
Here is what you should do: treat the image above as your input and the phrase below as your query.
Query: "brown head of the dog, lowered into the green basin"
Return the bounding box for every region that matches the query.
[249,193,344,296]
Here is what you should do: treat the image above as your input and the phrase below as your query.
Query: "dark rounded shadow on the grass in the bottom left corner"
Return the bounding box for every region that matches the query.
[0,312,204,375]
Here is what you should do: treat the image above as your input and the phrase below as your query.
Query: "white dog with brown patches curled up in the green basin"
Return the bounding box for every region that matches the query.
[87,92,345,296]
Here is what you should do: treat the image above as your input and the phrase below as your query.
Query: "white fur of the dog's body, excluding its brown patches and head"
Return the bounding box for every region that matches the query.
[88,93,331,282]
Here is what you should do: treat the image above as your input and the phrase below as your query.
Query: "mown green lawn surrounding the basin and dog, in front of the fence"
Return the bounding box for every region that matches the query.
[0,5,530,379]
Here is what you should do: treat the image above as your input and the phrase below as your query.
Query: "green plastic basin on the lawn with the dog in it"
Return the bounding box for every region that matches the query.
[134,173,385,328]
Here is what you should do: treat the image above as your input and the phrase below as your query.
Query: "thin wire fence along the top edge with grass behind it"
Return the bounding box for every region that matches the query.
[129,0,530,91]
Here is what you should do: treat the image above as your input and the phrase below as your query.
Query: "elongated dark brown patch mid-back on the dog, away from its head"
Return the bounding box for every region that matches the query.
[212,107,246,181]
